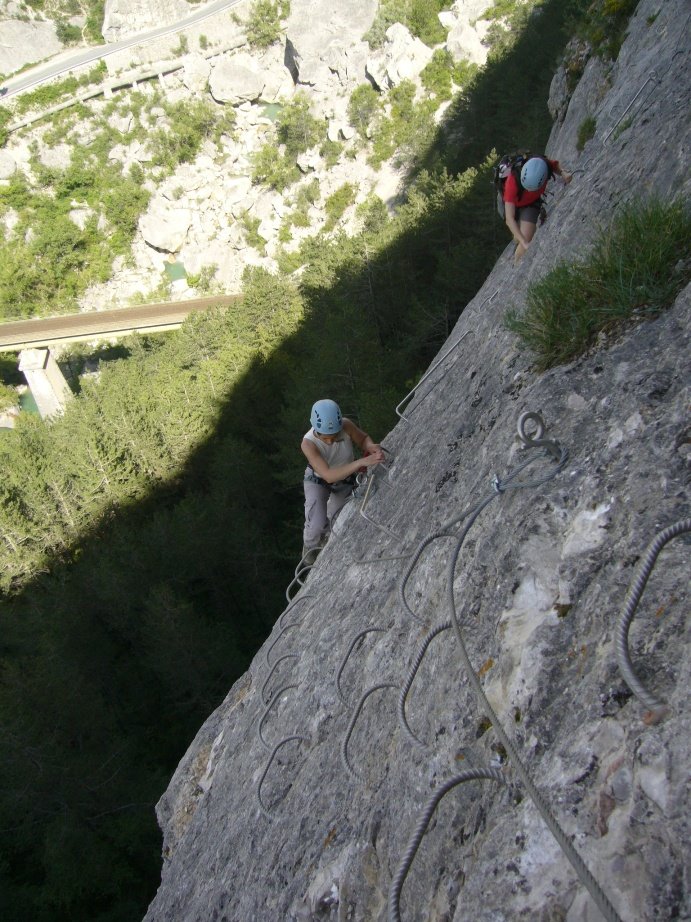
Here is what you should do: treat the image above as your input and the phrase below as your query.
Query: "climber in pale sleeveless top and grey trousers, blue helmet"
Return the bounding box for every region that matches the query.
[300,400,384,566]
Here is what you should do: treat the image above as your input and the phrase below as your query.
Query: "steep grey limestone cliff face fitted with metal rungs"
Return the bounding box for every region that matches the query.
[146,0,691,922]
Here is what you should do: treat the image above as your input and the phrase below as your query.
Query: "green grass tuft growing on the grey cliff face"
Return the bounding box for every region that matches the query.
[505,200,691,371]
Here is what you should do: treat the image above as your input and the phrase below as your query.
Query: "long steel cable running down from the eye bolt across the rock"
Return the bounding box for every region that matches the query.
[447,512,622,922]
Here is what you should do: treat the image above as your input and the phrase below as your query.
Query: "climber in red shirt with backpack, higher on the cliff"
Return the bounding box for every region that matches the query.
[499,157,572,265]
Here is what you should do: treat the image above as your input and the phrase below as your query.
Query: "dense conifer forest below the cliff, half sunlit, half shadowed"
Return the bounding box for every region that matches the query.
[0,0,631,922]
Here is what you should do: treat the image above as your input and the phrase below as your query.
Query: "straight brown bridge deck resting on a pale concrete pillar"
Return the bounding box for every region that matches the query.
[0,295,239,352]
